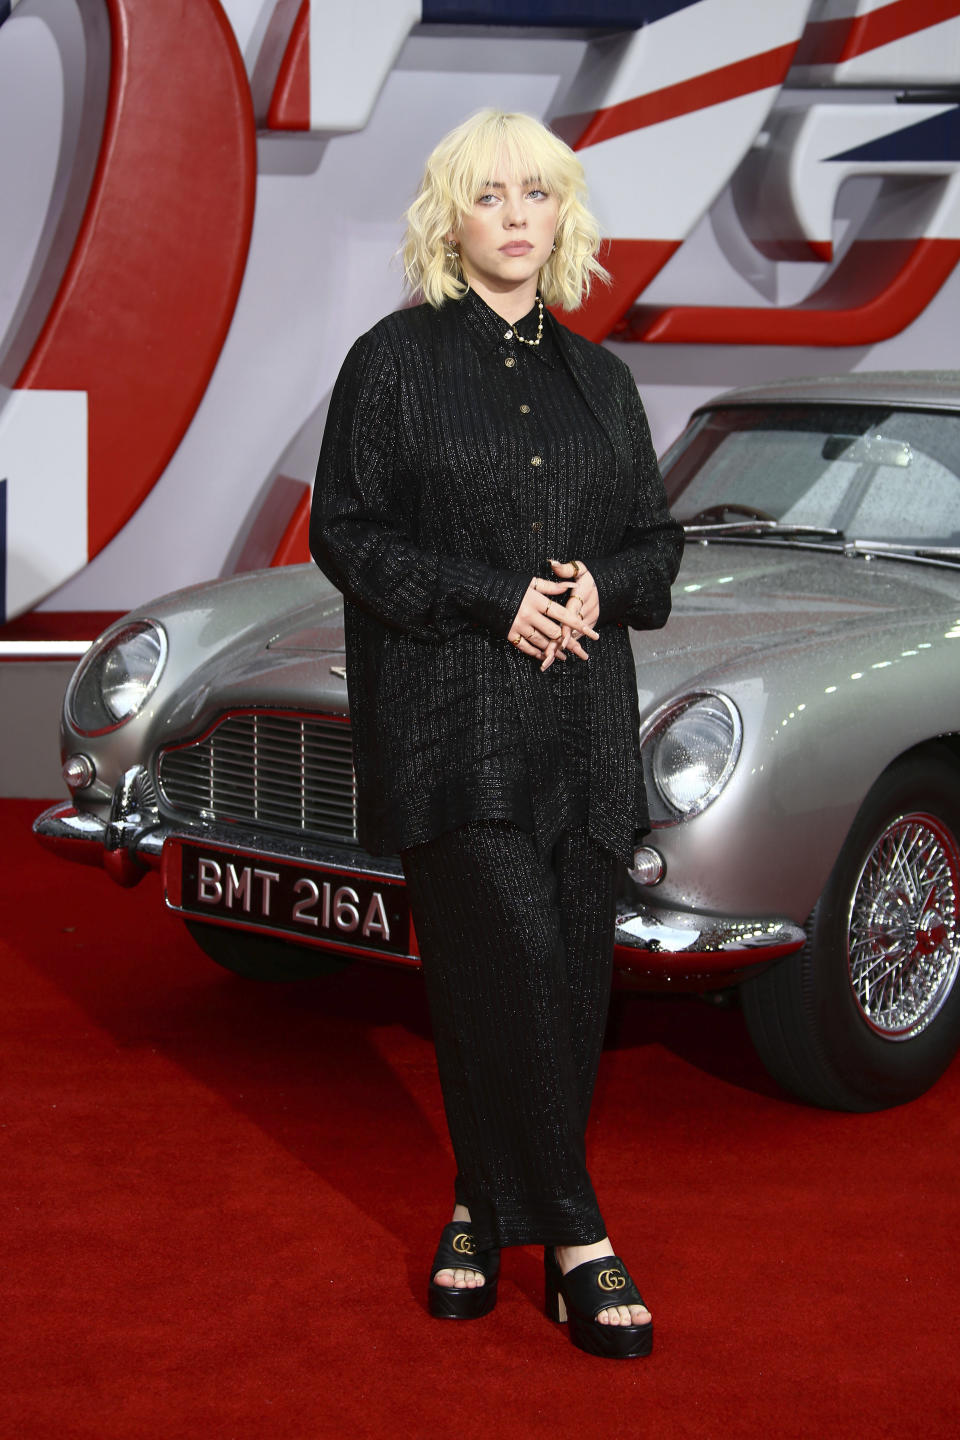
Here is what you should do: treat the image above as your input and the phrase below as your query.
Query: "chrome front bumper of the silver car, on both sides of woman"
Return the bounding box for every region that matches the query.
[33,786,806,991]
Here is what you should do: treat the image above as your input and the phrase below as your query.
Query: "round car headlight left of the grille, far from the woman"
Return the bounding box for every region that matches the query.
[66,621,167,734]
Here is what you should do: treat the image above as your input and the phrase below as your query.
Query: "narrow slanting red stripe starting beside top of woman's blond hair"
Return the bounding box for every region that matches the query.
[557,40,797,150]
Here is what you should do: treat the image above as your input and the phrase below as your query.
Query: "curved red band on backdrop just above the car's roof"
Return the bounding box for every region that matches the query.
[620,239,960,346]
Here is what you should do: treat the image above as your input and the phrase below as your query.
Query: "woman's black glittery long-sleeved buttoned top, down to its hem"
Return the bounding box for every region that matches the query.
[311,291,682,863]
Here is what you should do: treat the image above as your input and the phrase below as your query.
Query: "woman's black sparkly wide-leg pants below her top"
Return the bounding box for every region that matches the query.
[400,821,620,1248]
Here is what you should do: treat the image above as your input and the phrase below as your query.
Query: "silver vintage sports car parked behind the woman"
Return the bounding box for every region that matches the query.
[35,372,960,1110]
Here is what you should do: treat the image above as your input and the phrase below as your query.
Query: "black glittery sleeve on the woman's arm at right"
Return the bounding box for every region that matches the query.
[586,366,684,629]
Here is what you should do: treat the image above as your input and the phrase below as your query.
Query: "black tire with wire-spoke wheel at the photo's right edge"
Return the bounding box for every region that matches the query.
[741,750,960,1112]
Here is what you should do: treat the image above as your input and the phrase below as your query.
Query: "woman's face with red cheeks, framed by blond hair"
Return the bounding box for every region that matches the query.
[448,174,560,304]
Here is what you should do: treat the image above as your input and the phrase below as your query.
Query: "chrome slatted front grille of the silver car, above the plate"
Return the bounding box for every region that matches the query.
[157,711,357,842]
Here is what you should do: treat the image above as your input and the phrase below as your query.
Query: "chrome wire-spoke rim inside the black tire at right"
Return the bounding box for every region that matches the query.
[848,814,960,1040]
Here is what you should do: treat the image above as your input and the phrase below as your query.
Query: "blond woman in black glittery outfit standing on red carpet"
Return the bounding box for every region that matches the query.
[311,111,682,1358]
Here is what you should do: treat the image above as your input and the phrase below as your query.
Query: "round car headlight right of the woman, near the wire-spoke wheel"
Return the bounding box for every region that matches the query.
[642,691,743,819]
